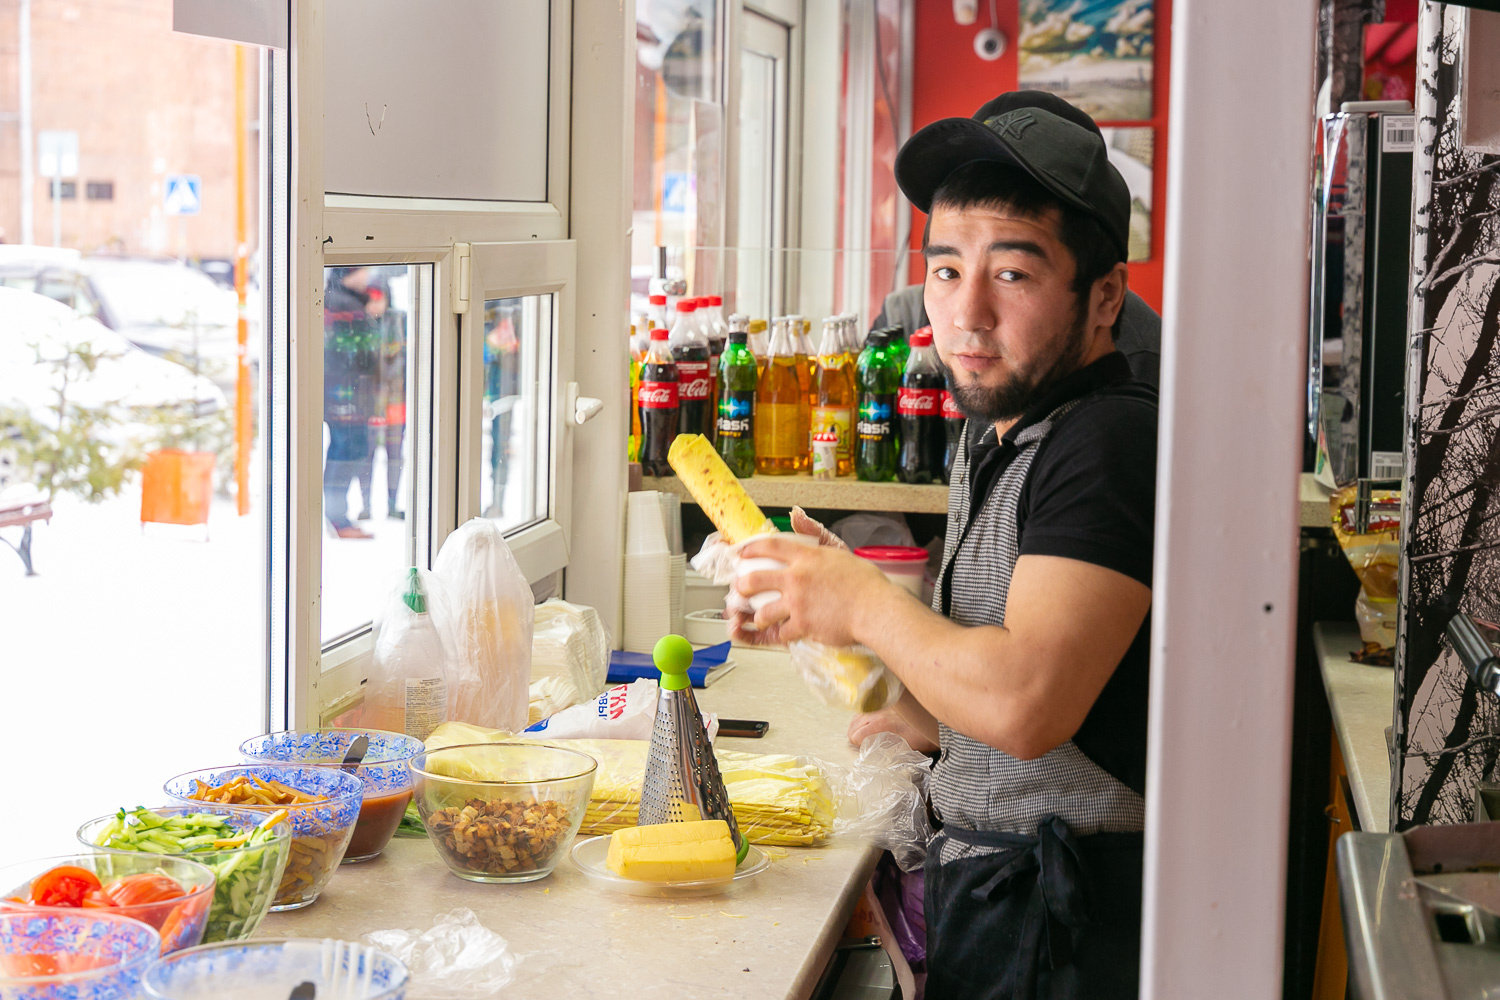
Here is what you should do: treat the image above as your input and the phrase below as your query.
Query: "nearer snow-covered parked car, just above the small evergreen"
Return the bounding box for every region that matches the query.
[0,288,225,423]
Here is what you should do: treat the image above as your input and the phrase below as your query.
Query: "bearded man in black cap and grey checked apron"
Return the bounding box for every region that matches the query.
[732,91,1157,1000]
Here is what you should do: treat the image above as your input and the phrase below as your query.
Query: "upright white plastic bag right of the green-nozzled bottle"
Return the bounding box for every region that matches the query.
[432,517,536,732]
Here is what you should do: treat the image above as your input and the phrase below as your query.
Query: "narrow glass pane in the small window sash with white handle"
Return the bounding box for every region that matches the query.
[480,295,555,531]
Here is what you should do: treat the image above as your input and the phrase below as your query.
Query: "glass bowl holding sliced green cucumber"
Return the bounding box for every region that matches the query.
[78,802,291,945]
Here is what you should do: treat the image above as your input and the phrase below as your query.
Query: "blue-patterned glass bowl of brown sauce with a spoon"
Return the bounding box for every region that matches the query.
[240,729,422,865]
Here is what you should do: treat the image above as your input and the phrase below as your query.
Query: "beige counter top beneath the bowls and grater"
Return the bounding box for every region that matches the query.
[260,649,879,1000]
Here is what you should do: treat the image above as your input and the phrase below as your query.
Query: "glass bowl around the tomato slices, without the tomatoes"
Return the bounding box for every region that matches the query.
[0,853,213,955]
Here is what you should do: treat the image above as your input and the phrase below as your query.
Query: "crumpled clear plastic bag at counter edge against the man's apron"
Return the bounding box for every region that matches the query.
[822,733,933,871]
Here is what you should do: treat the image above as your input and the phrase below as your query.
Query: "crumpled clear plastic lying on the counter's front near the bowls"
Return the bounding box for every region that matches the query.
[363,907,521,1000]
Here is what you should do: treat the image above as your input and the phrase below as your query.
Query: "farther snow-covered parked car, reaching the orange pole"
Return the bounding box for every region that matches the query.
[0,247,260,387]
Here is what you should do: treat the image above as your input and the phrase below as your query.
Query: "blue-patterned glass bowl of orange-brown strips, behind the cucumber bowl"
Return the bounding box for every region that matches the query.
[162,763,365,913]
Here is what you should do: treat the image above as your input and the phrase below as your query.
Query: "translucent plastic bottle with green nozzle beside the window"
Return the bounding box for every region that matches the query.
[360,568,461,739]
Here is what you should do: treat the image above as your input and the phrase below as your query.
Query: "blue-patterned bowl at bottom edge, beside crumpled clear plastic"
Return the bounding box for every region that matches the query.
[141,939,408,1000]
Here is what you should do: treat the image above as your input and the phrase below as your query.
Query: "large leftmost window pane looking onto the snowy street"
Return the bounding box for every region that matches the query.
[0,19,273,857]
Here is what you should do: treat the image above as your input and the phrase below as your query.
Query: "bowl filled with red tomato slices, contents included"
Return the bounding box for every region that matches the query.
[0,855,213,955]
